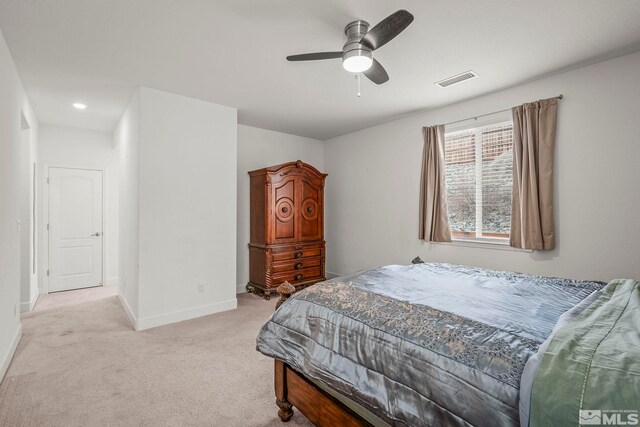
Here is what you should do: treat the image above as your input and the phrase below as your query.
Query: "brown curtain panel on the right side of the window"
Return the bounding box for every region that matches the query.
[509,98,558,250]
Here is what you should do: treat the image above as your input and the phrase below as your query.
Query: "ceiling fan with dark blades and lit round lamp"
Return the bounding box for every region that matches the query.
[287,10,413,84]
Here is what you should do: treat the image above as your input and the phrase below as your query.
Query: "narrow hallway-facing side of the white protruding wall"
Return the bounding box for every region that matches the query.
[113,91,140,320]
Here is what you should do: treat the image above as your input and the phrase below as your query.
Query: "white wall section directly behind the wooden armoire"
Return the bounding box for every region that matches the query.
[236,125,324,292]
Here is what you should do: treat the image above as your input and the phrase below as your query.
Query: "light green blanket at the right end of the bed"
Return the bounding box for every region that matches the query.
[530,280,640,427]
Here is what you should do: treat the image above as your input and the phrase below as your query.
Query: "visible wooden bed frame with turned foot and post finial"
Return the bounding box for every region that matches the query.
[275,282,371,427]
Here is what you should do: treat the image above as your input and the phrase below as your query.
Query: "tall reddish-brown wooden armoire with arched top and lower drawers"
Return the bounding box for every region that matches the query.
[247,160,327,299]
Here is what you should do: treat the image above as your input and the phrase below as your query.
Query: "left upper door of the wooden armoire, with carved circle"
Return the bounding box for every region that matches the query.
[271,177,298,243]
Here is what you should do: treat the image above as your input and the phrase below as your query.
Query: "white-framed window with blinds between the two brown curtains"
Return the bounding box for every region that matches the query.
[445,121,513,239]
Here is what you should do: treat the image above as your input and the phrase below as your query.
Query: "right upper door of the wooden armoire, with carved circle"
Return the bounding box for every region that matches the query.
[298,179,324,241]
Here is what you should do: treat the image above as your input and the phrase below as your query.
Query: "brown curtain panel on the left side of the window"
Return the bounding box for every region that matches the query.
[418,125,451,242]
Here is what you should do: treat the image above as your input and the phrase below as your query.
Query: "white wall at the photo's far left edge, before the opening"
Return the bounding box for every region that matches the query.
[0,28,37,380]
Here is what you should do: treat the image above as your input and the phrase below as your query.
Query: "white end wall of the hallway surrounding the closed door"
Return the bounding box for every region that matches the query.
[38,124,119,285]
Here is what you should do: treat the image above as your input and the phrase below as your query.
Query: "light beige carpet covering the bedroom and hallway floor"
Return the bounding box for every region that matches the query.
[0,287,311,427]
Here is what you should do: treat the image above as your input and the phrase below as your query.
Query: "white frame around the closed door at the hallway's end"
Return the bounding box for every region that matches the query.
[40,163,108,294]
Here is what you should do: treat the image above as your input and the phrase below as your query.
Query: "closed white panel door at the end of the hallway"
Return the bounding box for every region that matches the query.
[49,168,103,292]
